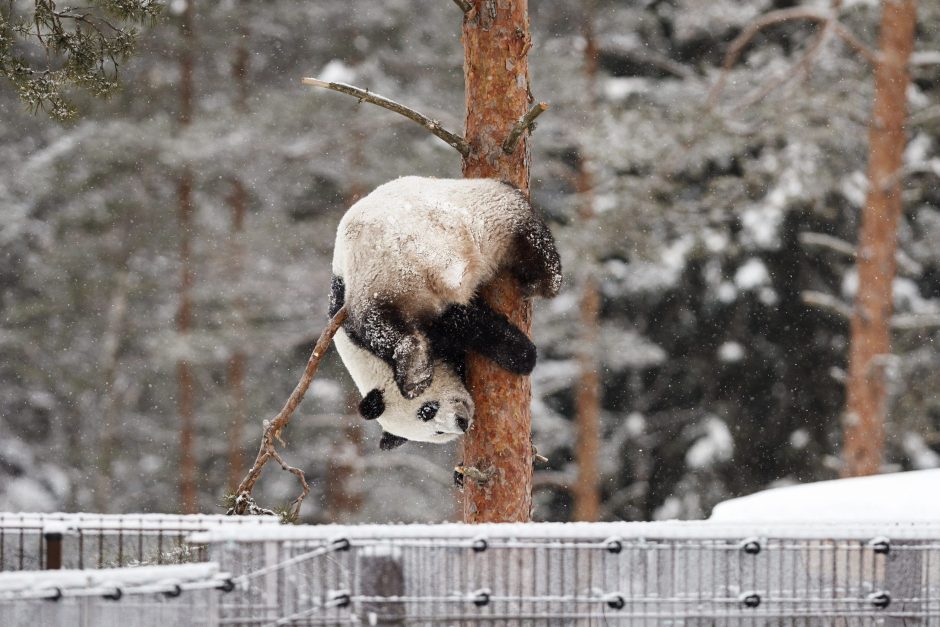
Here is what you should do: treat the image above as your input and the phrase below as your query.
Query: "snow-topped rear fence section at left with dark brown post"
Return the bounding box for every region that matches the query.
[0,512,279,572]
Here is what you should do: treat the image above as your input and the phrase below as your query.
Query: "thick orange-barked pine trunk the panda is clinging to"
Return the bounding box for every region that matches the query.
[463,0,532,522]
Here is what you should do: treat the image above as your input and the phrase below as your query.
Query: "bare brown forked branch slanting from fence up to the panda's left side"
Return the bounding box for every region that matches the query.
[228,306,346,516]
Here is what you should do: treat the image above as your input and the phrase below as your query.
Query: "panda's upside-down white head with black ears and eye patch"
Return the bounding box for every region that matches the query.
[359,362,474,450]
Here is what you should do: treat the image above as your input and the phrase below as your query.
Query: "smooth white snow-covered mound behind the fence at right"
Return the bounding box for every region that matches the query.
[711,469,940,525]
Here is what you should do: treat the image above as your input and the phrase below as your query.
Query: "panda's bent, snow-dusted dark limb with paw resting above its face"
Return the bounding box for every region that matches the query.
[345,303,434,399]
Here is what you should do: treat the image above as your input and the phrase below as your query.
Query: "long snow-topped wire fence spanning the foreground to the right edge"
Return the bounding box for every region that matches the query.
[192,522,940,627]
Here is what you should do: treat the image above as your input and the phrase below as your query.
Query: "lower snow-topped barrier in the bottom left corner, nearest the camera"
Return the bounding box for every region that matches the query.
[0,563,234,627]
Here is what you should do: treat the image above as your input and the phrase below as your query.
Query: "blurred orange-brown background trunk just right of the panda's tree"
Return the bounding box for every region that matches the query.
[574,0,601,522]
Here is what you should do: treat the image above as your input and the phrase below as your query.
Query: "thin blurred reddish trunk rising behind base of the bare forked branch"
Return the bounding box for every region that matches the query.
[228,26,248,490]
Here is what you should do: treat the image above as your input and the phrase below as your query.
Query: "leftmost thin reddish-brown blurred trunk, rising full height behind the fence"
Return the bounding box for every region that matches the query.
[176,0,197,514]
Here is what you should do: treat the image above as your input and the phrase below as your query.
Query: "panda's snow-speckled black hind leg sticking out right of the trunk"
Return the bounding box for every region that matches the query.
[509,212,561,298]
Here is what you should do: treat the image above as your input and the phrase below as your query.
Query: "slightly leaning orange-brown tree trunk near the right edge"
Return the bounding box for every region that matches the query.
[842,0,917,477]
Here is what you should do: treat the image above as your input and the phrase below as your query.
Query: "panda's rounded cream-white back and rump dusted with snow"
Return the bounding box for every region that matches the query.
[333,176,531,316]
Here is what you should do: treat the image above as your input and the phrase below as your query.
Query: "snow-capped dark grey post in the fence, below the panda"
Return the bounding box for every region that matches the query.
[356,546,406,625]
